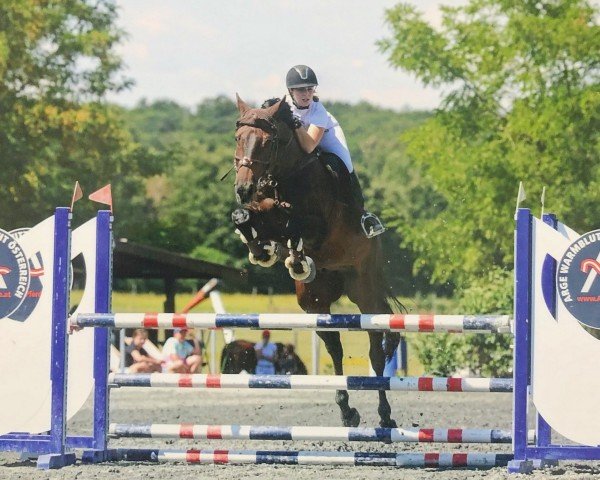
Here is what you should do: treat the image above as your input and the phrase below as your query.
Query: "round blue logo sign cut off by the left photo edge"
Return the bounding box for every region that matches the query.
[0,229,30,318]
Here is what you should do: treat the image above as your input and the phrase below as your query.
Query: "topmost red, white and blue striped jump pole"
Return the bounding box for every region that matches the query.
[71,313,511,333]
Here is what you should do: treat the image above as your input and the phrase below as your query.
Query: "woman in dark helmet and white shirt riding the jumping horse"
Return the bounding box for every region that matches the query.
[285,65,385,238]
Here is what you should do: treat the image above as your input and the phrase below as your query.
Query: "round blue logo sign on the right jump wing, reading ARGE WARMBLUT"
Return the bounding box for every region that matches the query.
[556,230,600,328]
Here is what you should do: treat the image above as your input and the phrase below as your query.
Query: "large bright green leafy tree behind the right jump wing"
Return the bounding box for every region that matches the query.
[379,0,600,285]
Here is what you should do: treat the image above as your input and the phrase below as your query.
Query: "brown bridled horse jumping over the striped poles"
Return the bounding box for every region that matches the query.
[232,95,403,428]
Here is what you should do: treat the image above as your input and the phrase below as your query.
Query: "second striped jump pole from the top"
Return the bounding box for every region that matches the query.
[108,373,513,393]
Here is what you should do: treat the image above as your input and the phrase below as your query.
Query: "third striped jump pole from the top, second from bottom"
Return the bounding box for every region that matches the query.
[109,423,534,443]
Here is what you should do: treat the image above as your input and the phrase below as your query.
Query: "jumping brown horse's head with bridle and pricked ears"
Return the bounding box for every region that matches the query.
[234,96,295,204]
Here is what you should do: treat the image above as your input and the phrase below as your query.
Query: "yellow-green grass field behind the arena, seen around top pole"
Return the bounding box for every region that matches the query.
[71,291,460,375]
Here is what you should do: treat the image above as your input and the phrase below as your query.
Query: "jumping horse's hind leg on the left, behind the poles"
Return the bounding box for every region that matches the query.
[296,271,360,427]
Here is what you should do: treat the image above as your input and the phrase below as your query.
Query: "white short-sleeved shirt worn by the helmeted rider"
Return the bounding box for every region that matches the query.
[290,100,354,173]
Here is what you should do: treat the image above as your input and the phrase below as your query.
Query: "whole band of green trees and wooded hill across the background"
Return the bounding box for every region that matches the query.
[0,0,600,304]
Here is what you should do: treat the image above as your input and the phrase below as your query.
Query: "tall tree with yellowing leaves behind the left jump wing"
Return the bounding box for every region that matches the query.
[0,0,156,228]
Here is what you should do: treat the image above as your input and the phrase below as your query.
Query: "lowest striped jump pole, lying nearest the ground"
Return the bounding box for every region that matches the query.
[106,448,513,468]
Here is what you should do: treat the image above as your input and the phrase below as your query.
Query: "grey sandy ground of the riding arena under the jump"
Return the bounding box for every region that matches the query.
[0,388,600,480]
